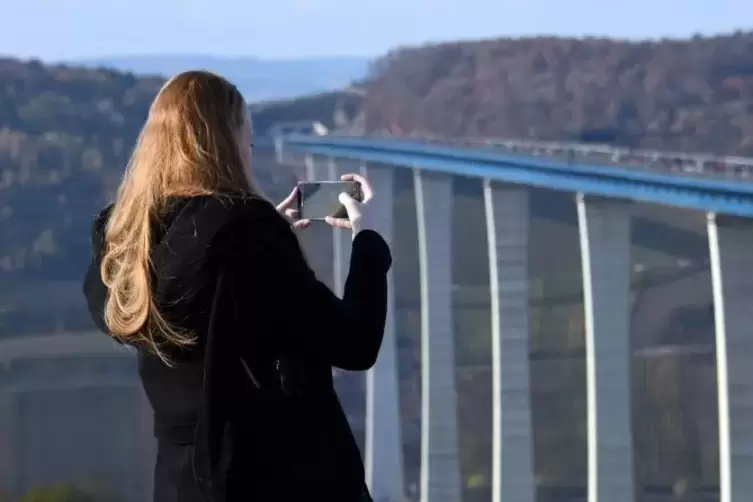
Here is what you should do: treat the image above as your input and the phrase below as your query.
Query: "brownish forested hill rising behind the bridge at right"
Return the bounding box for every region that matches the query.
[358,32,753,155]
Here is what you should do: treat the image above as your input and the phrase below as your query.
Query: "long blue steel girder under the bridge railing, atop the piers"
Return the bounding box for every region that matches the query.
[284,136,753,217]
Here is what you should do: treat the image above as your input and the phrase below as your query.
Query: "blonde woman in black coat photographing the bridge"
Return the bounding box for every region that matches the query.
[84,72,391,502]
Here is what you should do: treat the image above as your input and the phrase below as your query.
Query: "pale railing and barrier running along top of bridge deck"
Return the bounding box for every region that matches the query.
[331,131,753,181]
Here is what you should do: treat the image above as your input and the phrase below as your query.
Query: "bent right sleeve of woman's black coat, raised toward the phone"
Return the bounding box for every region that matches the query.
[226,227,392,370]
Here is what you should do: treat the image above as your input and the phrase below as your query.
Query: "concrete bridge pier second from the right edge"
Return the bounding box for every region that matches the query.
[577,194,636,502]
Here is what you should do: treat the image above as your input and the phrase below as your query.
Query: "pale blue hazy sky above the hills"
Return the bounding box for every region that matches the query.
[0,0,753,60]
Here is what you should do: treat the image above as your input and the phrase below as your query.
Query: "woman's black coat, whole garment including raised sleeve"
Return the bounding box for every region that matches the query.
[84,197,392,502]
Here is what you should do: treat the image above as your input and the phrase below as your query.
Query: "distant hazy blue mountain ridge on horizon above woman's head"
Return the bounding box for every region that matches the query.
[71,54,371,101]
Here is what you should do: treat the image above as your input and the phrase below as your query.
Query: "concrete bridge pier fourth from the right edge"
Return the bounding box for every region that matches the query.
[413,169,462,502]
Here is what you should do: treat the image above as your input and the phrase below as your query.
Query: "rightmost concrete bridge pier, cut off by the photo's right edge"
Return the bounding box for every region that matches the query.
[707,213,753,502]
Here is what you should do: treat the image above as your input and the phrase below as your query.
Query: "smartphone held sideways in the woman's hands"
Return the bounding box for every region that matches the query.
[298,181,363,220]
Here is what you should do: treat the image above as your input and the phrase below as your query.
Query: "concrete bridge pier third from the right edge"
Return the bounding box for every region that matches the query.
[484,180,536,502]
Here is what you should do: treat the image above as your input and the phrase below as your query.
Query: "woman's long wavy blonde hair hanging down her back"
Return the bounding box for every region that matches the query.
[100,71,257,364]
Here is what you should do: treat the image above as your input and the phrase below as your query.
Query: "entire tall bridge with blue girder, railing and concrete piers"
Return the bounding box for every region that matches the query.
[275,135,753,502]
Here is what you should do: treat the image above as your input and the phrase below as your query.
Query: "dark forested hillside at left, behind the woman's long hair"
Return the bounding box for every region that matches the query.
[0,58,302,337]
